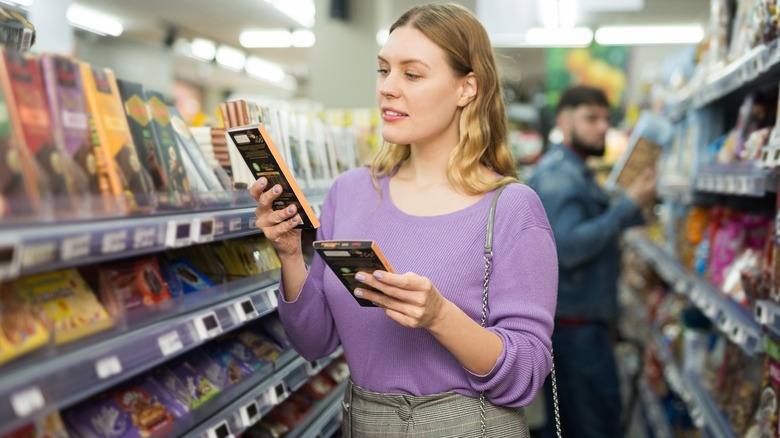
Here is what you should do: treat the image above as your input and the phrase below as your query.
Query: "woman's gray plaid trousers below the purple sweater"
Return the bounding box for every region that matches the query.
[341,380,529,438]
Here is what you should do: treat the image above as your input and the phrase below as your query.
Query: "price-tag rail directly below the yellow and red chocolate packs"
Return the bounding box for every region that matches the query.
[0,271,278,434]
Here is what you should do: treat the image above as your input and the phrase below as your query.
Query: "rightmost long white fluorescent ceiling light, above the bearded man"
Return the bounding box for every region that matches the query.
[596,24,704,46]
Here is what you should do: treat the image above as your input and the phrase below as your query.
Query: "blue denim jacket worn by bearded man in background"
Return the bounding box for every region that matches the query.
[529,145,644,322]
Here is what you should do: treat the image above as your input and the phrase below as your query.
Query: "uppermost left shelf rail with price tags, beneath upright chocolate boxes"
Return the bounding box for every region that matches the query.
[0,192,324,280]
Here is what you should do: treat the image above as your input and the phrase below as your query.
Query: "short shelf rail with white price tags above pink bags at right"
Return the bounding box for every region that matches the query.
[696,162,777,197]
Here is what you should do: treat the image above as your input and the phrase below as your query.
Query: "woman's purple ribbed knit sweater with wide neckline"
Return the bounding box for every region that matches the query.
[279,168,558,406]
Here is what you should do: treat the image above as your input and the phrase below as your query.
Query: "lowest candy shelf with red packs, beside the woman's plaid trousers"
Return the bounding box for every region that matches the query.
[243,356,349,438]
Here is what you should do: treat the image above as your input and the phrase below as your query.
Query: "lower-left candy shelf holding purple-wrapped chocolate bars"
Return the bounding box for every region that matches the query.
[0,314,322,438]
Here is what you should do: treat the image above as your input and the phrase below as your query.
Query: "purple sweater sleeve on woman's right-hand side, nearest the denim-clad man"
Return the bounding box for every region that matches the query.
[468,188,558,406]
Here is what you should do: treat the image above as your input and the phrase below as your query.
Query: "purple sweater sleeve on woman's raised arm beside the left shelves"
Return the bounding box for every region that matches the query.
[278,180,341,360]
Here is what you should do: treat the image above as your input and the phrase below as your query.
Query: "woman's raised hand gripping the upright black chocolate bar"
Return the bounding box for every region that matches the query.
[249,178,302,259]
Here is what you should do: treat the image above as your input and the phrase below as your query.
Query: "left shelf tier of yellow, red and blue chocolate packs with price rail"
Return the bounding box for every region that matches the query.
[0,238,281,433]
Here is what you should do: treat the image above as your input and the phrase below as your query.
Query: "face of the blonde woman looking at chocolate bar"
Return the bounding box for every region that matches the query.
[376,26,476,152]
